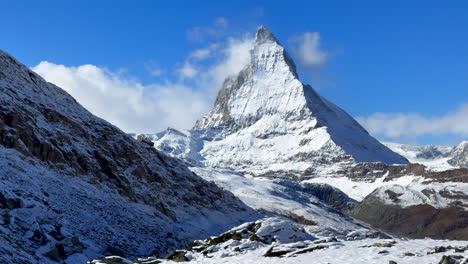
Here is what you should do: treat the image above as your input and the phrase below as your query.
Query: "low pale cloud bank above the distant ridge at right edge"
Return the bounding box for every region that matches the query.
[356,104,468,138]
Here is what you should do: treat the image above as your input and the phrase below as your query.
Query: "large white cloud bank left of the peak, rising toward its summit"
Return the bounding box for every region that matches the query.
[32,35,252,133]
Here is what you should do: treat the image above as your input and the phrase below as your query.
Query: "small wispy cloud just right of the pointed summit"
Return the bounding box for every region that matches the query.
[289,32,327,66]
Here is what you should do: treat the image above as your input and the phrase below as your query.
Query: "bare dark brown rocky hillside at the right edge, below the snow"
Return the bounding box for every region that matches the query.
[348,194,468,240]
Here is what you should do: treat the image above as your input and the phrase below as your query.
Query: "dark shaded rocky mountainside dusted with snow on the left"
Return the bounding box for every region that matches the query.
[0,51,259,263]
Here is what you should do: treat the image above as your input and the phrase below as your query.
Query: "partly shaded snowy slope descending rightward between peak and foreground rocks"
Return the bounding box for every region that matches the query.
[191,167,366,236]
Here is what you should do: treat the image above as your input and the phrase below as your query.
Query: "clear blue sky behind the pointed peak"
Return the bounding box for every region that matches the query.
[0,1,468,144]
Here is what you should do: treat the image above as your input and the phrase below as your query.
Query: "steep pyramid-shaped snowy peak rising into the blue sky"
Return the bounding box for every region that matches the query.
[155,26,408,177]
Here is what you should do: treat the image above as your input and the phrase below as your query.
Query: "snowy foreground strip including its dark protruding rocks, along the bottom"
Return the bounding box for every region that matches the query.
[90,232,468,264]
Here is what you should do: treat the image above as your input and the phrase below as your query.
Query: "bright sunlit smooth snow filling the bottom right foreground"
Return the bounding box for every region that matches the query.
[171,239,468,264]
